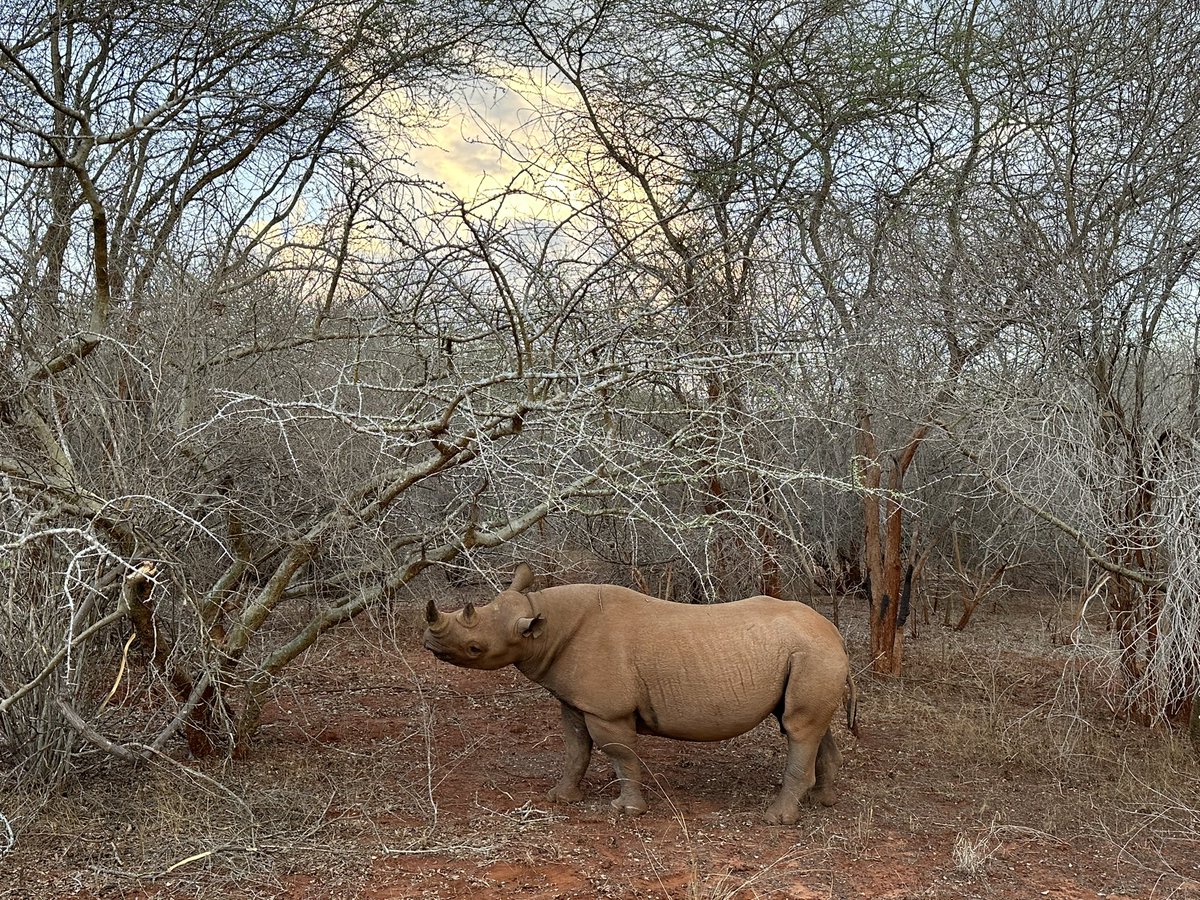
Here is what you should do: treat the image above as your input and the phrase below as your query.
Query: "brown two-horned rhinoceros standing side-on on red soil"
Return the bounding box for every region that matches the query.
[424,564,856,824]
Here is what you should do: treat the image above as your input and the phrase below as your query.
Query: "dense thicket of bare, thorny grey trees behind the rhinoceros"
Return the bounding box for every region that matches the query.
[0,0,1200,801]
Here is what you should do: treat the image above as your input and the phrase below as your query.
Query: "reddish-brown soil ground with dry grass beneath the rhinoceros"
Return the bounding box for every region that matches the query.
[0,592,1200,900]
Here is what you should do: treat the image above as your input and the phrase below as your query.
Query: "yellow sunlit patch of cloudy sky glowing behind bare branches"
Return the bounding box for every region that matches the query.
[246,64,650,316]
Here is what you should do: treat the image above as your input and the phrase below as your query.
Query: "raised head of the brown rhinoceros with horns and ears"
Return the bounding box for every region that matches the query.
[424,563,545,668]
